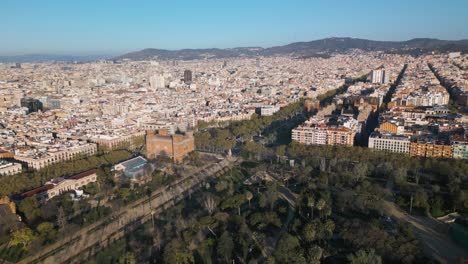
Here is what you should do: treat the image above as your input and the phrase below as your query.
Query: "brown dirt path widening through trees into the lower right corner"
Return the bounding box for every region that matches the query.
[383,201,468,264]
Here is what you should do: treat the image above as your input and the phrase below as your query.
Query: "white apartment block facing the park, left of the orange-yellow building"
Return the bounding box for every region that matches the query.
[369,132,410,154]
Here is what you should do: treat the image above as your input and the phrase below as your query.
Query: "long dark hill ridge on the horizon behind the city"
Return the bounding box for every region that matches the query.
[116,38,468,60]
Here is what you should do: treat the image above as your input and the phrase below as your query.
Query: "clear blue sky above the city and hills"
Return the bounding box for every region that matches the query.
[0,0,468,55]
